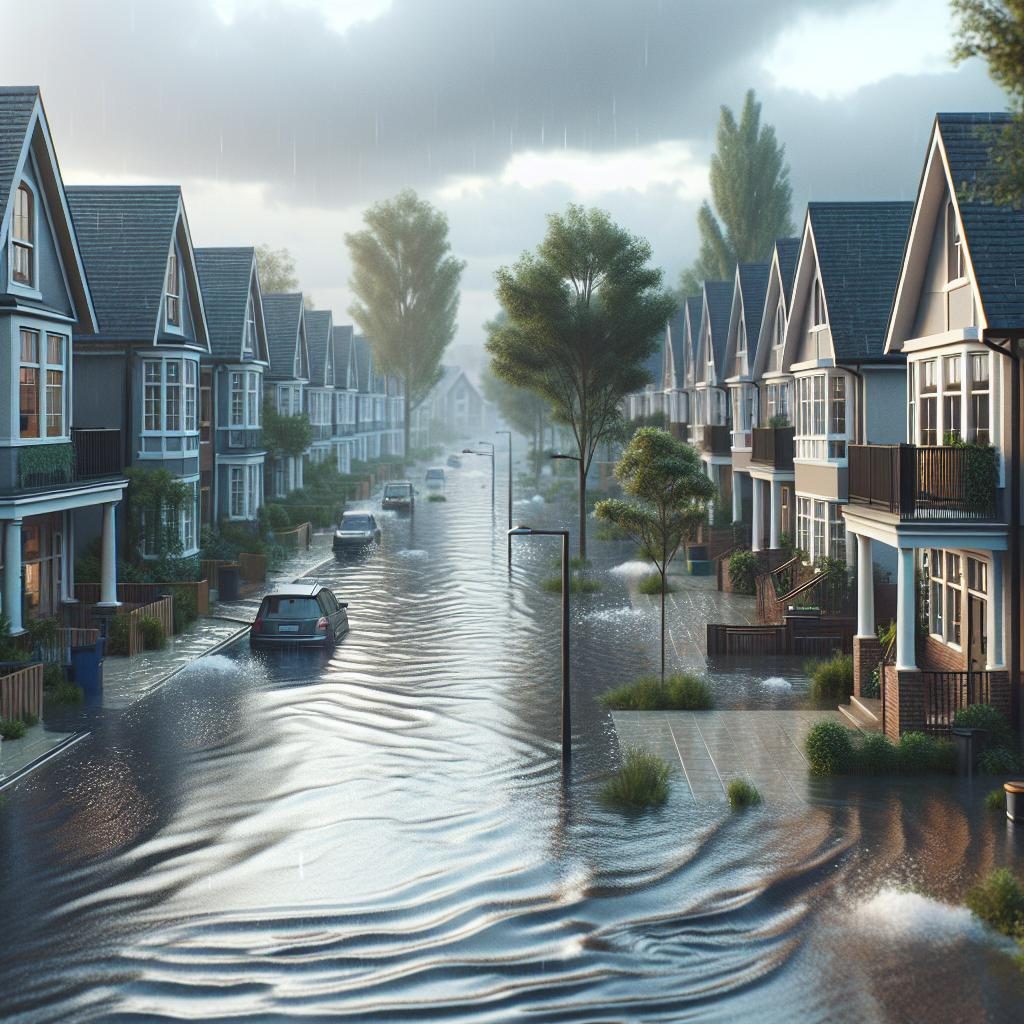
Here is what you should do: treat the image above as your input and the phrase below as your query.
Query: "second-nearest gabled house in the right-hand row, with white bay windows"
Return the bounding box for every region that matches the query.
[782,203,913,563]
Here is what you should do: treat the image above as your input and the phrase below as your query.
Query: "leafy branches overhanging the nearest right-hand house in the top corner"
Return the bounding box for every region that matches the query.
[952,0,1024,205]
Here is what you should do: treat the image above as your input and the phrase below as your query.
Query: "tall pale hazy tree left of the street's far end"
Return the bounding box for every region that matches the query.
[345,188,465,452]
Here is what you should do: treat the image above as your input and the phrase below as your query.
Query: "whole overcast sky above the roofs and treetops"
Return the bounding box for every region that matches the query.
[0,0,1005,372]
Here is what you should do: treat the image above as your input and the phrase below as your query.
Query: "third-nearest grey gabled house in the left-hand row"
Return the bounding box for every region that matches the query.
[196,247,270,524]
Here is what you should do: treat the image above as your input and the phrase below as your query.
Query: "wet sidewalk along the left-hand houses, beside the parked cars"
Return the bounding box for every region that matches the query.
[0,532,332,791]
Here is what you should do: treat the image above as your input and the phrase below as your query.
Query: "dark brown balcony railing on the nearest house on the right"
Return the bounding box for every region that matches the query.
[849,444,998,520]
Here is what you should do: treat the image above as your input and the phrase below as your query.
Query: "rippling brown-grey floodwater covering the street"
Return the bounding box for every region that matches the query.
[0,472,1024,1024]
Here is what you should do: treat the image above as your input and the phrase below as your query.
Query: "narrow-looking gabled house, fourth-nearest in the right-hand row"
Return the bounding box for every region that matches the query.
[723,263,769,522]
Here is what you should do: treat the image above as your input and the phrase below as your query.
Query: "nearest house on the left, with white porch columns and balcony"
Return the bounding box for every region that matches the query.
[0,87,128,634]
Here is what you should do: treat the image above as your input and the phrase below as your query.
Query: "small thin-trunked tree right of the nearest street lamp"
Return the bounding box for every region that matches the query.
[594,427,716,685]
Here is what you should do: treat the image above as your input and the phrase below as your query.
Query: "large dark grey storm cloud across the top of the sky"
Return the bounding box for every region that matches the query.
[16,0,856,206]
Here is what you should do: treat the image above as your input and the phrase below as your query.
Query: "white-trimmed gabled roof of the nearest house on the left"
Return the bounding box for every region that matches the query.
[0,85,96,332]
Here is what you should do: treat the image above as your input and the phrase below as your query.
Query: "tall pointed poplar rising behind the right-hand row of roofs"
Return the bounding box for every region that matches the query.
[680,89,793,295]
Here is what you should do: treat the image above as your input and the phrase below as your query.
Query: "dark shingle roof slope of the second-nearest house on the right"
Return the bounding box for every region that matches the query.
[807,203,913,362]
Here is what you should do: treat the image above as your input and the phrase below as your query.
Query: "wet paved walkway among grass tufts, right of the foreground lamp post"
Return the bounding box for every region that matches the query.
[611,710,842,804]
